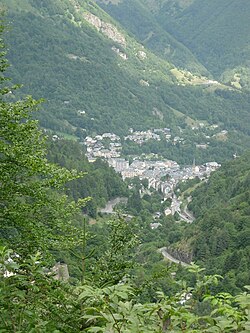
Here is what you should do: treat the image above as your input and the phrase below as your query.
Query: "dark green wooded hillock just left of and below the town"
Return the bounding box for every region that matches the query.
[48,140,128,218]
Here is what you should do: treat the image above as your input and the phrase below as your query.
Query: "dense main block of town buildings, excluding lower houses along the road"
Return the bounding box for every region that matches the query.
[84,128,220,197]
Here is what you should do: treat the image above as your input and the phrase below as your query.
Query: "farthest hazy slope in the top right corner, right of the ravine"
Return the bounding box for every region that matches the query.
[138,0,250,89]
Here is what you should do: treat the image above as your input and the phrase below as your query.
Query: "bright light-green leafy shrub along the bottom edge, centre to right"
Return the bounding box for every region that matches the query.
[78,266,250,333]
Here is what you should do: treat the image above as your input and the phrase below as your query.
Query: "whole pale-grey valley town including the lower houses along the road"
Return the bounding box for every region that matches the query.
[84,128,220,222]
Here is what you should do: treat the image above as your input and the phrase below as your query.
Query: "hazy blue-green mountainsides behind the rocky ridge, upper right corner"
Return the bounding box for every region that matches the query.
[97,0,250,89]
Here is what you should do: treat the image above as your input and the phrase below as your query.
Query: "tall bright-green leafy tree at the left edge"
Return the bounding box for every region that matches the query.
[0,23,86,253]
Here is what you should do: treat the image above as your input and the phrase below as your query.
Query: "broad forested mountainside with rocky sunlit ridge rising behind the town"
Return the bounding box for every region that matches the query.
[2,0,250,158]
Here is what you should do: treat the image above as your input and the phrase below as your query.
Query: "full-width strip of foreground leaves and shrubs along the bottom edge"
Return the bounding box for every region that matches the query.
[0,244,250,333]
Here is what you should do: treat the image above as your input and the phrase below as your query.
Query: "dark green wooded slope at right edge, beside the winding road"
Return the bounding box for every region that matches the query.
[189,152,250,292]
